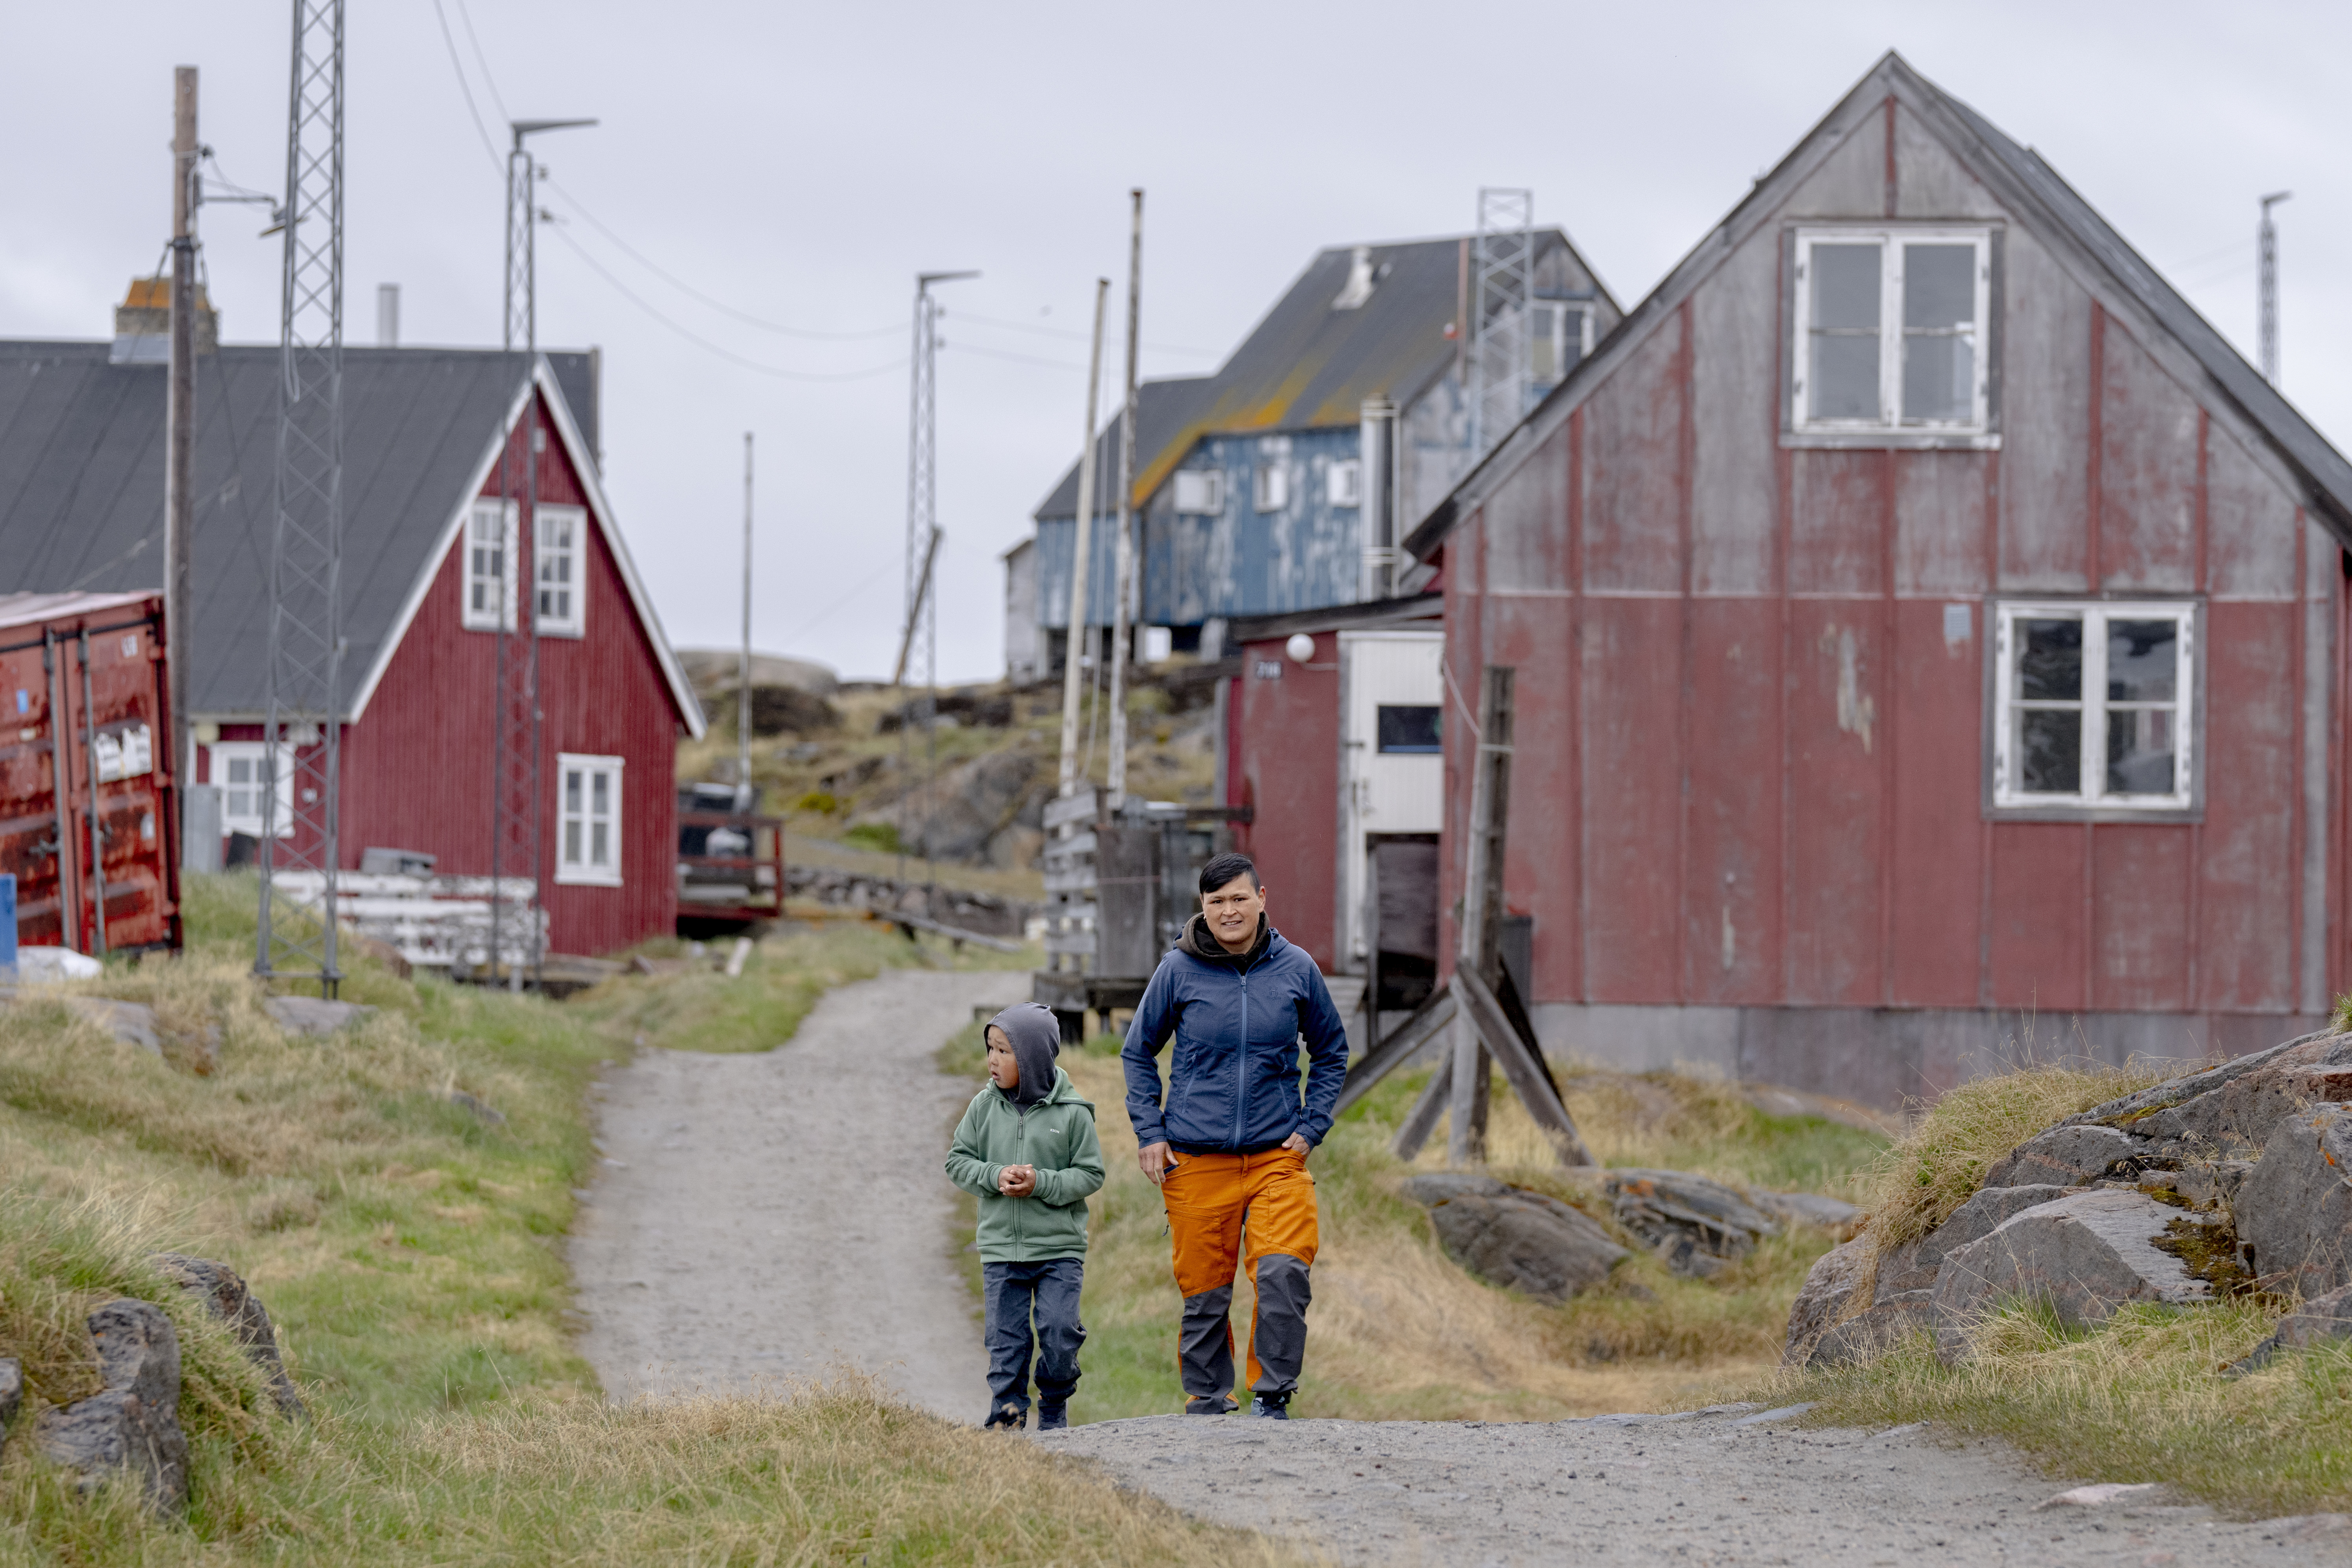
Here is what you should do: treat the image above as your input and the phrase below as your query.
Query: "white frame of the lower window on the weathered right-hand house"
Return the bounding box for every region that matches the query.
[1992,599,2199,813]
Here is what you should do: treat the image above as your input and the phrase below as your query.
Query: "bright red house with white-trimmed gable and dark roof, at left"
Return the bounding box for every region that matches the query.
[0,343,703,952]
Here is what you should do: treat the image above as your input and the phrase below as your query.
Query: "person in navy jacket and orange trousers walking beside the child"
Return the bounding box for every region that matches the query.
[1120,856,1348,1420]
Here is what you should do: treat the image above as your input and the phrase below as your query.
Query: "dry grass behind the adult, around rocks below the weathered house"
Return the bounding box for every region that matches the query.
[941,1030,1882,1420]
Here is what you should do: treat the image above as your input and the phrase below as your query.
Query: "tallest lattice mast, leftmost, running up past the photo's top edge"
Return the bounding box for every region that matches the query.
[254,0,343,999]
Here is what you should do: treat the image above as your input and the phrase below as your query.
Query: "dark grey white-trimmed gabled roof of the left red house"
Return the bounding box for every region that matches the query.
[0,341,701,729]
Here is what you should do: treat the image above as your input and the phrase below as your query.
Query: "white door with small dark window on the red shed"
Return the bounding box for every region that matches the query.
[1338,633,1447,973]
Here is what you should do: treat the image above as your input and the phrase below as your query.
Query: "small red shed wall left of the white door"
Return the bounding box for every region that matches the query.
[1225,633,1338,973]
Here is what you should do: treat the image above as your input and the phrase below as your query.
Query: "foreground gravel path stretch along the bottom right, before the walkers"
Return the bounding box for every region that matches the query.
[1035,1406,2352,1568]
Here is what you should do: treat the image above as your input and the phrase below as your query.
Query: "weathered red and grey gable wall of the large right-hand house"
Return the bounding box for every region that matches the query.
[1430,95,2347,1044]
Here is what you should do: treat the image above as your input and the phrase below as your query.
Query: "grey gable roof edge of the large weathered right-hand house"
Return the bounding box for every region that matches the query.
[1404,49,2352,560]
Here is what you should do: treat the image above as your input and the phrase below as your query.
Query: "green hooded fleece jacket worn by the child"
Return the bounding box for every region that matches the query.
[948,1067,1103,1262]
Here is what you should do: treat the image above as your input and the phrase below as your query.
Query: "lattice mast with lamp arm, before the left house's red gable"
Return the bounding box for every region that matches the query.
[489,120,595,990]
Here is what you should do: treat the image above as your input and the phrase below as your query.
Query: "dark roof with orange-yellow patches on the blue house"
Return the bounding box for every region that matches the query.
[1033,228,1618,517]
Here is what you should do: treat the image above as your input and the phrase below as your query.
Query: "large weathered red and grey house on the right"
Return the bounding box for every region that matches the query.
[1409,54,2352,1102]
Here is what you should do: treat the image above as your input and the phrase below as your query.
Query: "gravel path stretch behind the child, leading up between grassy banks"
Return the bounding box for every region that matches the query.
[571,969,1028,1420]
